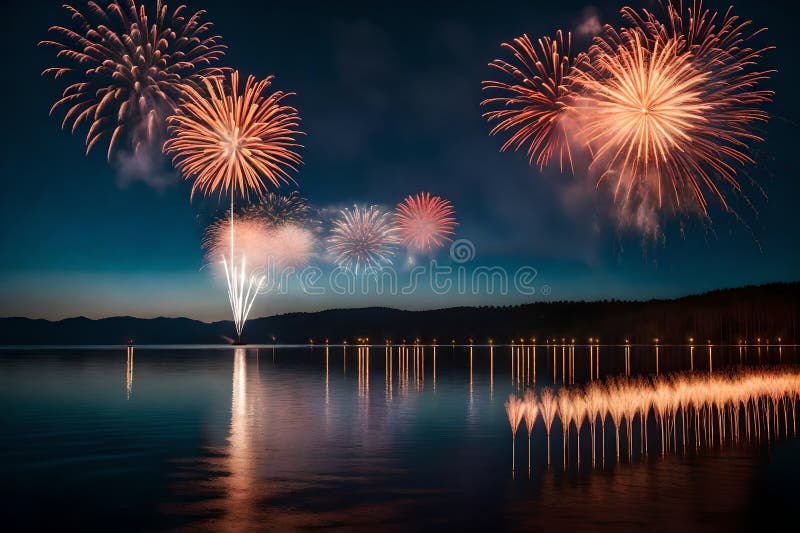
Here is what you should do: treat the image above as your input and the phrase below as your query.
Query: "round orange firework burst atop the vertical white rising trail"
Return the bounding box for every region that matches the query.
[164,71,302,201]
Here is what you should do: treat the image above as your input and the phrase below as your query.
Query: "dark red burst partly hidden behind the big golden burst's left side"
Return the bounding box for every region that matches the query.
[481,31,585,171]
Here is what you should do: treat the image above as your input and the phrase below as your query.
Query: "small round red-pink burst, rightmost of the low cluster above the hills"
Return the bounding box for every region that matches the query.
[394,192,457,253]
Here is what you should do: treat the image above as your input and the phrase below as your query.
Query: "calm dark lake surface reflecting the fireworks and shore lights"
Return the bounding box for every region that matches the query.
[0,346,800,531]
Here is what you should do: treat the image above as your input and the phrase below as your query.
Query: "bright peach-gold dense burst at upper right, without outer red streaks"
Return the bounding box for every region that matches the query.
[581,31,712,208]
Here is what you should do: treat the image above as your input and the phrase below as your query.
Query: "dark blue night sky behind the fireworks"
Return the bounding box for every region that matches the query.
[0,0,800,320]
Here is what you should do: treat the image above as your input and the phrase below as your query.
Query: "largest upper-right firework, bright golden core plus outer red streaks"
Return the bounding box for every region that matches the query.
[575,2,772,213]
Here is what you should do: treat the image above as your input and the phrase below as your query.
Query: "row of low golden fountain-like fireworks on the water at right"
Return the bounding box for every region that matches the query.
[505,366,800,475]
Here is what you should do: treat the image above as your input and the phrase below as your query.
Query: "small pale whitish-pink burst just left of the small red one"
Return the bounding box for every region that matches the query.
[328,206,400,274]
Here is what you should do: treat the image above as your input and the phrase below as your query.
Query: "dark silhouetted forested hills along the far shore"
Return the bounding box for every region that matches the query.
[0,282,800,345]
